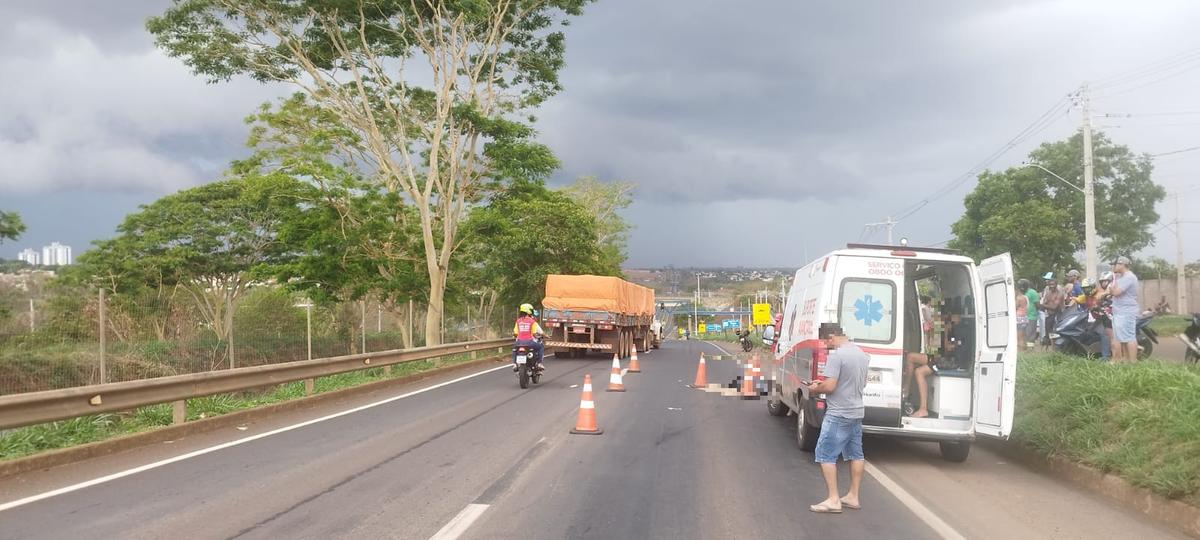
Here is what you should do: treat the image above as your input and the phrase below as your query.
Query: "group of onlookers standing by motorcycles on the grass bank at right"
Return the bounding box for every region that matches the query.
[1016,257,1140,362]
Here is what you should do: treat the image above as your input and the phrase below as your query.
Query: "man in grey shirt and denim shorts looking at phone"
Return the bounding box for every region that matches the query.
[808,323,870,514]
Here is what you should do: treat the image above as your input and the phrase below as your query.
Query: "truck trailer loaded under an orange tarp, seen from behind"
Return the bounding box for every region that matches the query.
[541,275,659,358]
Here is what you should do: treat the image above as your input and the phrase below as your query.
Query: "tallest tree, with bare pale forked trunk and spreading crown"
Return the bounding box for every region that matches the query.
[146,0,589,344]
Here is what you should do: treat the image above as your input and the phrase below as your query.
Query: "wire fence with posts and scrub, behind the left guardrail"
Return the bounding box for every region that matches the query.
[0,280,498,395]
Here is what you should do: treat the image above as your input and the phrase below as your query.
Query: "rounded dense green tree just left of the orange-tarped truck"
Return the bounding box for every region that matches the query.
[462,182,620,324]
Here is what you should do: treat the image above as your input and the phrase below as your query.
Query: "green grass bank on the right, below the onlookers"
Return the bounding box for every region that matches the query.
[1013,354,1200,504]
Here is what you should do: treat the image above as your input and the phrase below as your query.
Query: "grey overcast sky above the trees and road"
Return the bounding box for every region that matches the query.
[0,0,1200,266]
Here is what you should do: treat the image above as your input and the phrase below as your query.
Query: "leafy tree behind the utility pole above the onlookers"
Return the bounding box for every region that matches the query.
[950,133,1165,277]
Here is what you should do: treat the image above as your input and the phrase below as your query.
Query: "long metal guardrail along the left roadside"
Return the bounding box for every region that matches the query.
[0,338,512,430]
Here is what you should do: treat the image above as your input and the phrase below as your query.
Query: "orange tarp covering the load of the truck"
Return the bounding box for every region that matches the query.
[541,274,654,316]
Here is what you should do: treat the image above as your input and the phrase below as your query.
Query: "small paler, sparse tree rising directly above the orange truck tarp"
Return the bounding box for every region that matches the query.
[563,176,634,272]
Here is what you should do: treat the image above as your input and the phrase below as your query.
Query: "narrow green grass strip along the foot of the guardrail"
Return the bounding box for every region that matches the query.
[0,354,487,461]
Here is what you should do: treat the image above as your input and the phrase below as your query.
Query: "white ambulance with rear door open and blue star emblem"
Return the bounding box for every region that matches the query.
[768,245,1018,462]
